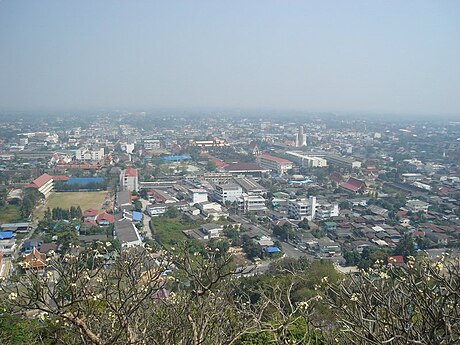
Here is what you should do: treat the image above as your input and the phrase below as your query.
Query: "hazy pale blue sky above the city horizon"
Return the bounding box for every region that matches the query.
[0,0,460,117]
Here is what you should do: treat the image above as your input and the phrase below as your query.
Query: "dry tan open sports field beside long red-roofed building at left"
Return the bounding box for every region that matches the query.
[38,192,107,219]
